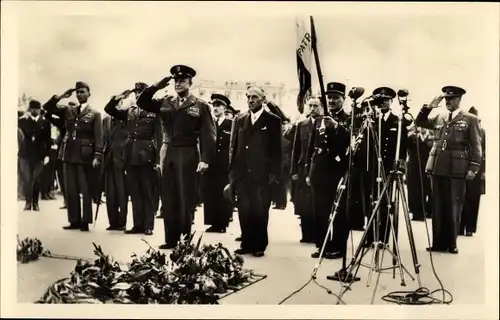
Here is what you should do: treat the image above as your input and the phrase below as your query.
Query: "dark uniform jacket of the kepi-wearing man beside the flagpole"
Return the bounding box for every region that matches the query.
[306,117,349,184]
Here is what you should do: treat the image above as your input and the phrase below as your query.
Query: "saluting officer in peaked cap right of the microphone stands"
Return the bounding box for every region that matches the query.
[415,86,482,254]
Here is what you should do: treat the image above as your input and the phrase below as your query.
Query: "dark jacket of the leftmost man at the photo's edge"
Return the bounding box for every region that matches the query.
[18,113,52,163]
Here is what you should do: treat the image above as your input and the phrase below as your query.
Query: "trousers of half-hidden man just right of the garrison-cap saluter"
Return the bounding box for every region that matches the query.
[104,161,128,228]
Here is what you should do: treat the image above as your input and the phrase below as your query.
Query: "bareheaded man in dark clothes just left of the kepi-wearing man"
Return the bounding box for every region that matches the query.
[290,98,323,243]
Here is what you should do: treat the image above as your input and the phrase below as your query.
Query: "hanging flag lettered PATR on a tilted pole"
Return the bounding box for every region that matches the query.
[296,18,312,113]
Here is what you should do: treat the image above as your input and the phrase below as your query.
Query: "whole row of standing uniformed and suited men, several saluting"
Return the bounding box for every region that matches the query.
[18,65,485,259]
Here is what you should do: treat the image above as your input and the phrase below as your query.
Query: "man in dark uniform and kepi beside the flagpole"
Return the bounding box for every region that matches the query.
[306,82,349,259]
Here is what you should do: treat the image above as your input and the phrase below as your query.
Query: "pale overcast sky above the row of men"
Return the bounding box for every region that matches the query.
[19,3,498,124]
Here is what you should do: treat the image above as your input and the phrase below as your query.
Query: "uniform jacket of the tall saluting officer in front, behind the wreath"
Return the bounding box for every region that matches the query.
[137,86,217,164]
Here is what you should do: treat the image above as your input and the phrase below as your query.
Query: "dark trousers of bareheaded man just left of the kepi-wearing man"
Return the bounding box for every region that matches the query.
[294,167,315,241]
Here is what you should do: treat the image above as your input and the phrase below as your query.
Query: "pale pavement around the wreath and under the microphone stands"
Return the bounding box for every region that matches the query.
[17,195,485,305]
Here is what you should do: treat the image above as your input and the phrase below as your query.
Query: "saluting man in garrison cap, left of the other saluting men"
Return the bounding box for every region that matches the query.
[43,81,103,231]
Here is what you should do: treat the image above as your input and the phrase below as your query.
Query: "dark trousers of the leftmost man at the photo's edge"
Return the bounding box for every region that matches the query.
[19,158,43,203]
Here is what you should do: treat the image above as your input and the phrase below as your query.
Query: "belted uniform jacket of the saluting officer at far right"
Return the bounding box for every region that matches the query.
[415,108,482,178]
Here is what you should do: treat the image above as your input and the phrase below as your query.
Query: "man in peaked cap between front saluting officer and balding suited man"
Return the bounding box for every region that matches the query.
[201,93,233,233]
